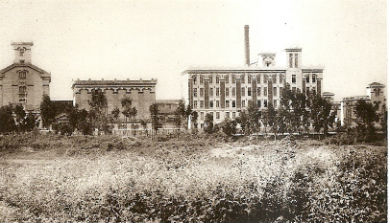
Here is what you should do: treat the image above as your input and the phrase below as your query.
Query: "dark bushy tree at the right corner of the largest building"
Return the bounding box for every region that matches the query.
[310,94,335,137]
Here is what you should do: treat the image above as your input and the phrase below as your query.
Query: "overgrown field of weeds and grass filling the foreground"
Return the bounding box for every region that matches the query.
[0,134,387,222]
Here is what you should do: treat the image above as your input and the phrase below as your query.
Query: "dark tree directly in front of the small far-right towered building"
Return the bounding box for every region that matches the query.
[354,99,378,141]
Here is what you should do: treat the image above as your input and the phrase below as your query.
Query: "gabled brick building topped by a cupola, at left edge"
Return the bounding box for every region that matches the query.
[0,42,51,113]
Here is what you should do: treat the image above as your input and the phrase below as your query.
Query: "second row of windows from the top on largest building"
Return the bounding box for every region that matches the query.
[193,87,282,97]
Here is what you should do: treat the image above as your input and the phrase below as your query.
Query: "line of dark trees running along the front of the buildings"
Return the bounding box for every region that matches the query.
[0,87,387,139]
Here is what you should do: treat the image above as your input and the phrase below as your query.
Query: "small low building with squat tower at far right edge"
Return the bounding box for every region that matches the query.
[340,82,386,128]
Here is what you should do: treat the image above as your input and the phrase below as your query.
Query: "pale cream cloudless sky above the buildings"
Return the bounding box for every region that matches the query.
[0,0,387,100]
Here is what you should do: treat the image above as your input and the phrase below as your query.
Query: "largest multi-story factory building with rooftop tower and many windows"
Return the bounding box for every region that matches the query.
[184,48,323,128]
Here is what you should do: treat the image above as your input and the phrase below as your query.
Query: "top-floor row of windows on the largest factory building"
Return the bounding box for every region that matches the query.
[192,74,284,85]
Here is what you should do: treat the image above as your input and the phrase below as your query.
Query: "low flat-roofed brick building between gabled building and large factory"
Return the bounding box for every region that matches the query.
[72,79,157,121]
